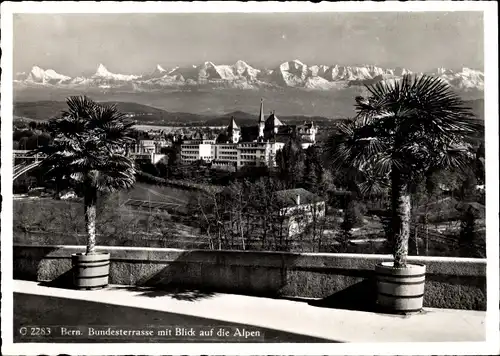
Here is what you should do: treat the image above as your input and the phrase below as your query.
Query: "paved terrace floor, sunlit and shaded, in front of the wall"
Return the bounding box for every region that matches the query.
[13,280,486,343]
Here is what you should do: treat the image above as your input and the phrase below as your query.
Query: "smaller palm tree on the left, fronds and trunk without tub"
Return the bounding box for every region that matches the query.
[36,96,135,254]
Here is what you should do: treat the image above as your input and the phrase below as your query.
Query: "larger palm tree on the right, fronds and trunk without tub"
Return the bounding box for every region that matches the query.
[326,75,482,268]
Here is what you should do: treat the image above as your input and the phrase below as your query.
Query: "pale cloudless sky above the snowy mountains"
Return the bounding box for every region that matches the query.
[14,12,484,76]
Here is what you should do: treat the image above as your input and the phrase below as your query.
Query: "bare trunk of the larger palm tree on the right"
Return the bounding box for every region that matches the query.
[391,169,411,268]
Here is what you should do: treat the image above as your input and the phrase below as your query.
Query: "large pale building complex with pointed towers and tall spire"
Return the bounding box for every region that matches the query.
[181,101,317,169]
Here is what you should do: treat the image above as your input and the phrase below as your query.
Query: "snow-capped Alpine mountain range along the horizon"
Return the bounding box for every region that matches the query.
[14,59,484,92]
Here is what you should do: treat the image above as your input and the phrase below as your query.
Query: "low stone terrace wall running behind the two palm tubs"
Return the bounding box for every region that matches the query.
[13,246,486,310]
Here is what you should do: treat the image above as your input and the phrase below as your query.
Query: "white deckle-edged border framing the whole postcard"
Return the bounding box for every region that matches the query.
[1,1,500,355]
